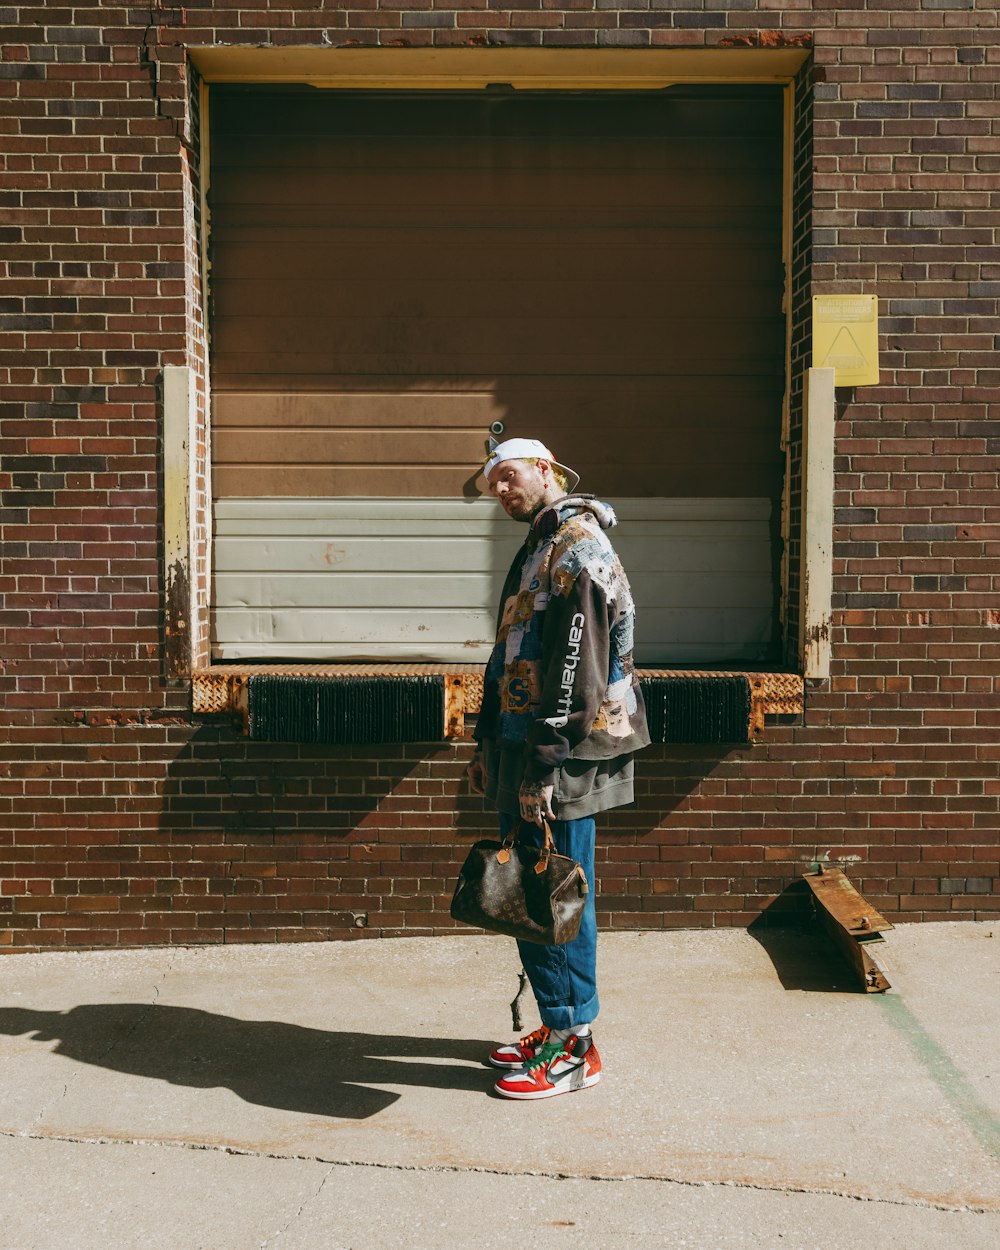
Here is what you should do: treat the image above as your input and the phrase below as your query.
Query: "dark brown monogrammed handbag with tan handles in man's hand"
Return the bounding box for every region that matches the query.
[451,821,589,946]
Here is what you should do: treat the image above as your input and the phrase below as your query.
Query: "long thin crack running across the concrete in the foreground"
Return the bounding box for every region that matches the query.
[0,1129,1000,1215]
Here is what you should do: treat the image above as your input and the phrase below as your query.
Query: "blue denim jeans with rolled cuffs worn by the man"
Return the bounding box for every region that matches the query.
[500,811,600,1029]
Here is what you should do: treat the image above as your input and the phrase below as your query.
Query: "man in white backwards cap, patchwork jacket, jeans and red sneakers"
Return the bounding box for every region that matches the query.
[468,439,649,1099]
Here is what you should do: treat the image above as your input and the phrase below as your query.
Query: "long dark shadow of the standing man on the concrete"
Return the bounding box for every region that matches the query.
[0,1003,495,1120]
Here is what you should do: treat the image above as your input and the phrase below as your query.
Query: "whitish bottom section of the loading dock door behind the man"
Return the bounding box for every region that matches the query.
[213,496,774,665]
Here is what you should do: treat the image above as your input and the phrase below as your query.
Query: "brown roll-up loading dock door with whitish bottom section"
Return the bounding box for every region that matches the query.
[210,88,785,664]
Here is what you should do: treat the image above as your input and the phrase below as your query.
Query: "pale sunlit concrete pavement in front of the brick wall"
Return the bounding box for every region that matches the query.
[0,924,1000,1250]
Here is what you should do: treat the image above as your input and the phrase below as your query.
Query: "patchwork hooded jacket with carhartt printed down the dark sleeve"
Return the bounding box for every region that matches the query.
[475,495,650,783]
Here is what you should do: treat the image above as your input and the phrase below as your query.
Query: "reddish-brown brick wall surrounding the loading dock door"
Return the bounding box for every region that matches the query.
[0,0,1000,950]
